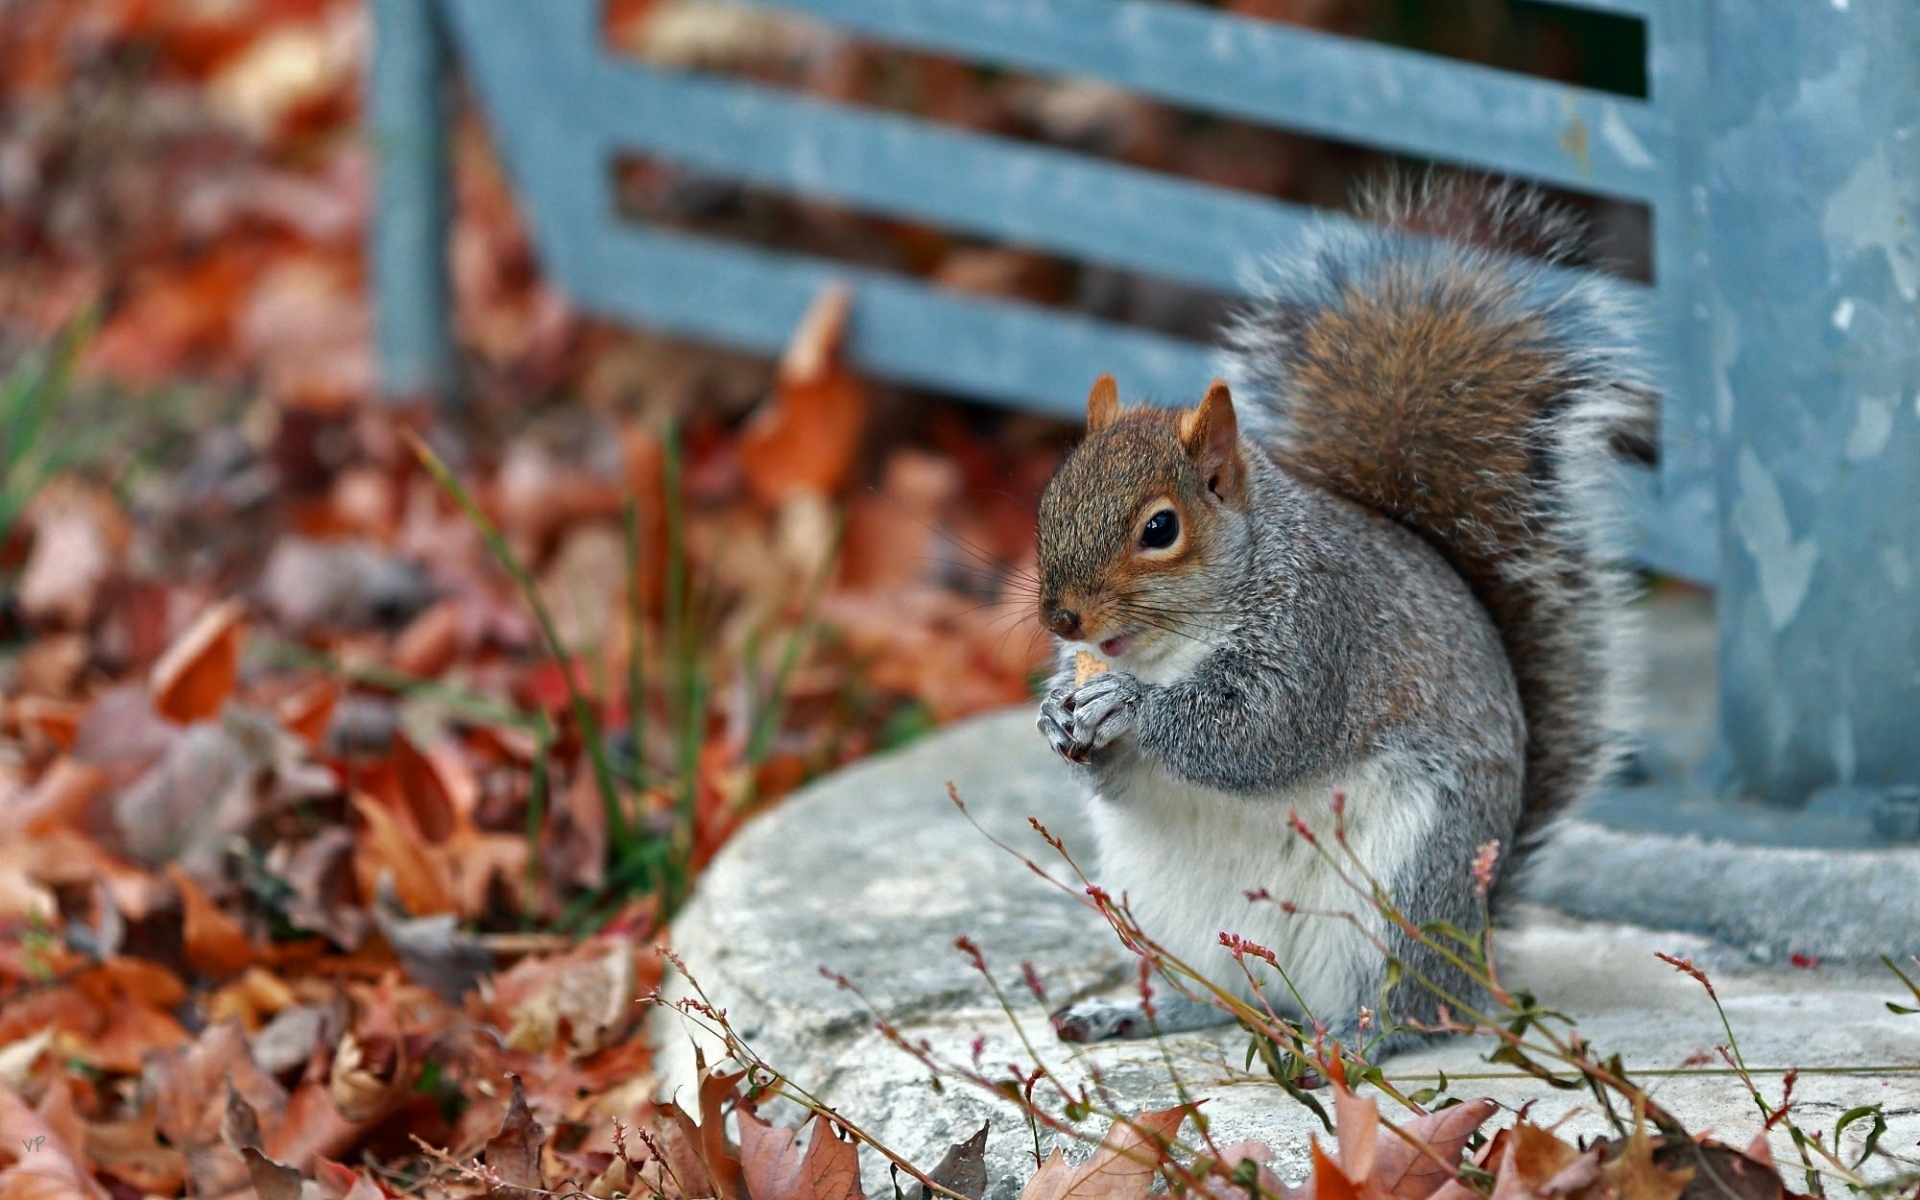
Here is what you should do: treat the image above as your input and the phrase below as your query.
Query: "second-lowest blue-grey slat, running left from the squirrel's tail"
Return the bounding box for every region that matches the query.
[591,62,1315,292]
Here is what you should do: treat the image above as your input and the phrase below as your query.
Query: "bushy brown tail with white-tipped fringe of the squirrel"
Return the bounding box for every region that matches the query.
[1235,179,1653,860]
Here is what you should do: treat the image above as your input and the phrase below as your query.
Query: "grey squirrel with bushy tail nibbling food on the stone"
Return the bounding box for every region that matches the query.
[1037,179,1653,1054]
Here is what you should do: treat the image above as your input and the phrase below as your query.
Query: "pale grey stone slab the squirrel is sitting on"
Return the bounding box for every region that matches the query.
[657,710,1920,1198]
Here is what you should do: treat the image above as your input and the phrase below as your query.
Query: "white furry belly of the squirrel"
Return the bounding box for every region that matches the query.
[1091,755,1438,1025]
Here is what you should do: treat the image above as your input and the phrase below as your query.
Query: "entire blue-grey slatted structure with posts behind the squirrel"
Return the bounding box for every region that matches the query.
[372,0,1920,840]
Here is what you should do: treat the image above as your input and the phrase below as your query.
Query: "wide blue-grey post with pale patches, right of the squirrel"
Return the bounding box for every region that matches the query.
[1707,0,1920,803]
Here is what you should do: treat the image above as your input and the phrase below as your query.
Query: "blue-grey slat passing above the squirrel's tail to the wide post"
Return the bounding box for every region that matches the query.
[741,0,1670,200]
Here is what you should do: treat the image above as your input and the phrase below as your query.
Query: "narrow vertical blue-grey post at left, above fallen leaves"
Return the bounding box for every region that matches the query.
[367,0,453,401]
